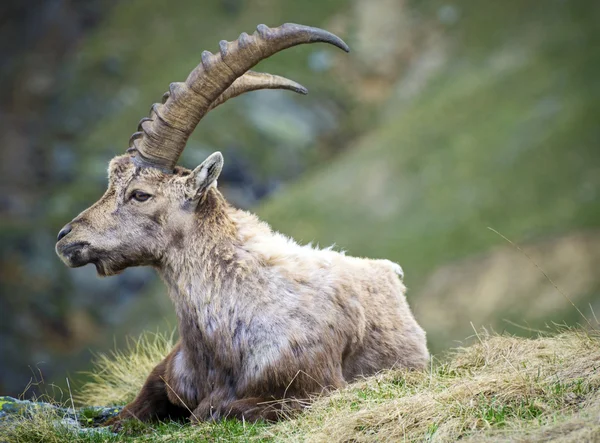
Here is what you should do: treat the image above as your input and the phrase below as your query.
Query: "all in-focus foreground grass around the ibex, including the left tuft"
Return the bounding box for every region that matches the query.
[0,329,600,443]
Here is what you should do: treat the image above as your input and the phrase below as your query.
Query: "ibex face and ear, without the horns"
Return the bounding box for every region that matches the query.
[56,152,223,275]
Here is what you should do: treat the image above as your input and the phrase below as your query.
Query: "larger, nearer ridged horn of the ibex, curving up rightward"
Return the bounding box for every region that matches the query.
[129,23,349,173]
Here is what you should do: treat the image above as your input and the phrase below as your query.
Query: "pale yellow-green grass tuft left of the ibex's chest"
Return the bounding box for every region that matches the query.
[75,332,174,406]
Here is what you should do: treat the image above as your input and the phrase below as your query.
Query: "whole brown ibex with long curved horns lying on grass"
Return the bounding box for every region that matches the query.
[56,24,429,425]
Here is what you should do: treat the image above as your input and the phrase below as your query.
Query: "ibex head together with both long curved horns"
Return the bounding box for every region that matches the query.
[56,24,348,275]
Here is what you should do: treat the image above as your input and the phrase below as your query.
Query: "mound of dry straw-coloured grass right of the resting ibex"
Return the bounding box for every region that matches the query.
[265,331,600,443]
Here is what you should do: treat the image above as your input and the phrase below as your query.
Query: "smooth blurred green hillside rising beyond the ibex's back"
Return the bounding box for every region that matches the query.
[259,1,600,350]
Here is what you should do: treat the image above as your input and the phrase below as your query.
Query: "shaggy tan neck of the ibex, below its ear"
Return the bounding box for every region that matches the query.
[159,191,268,349]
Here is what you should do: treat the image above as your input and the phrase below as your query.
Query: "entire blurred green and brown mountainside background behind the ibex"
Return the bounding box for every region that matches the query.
[0,0,600,396]
